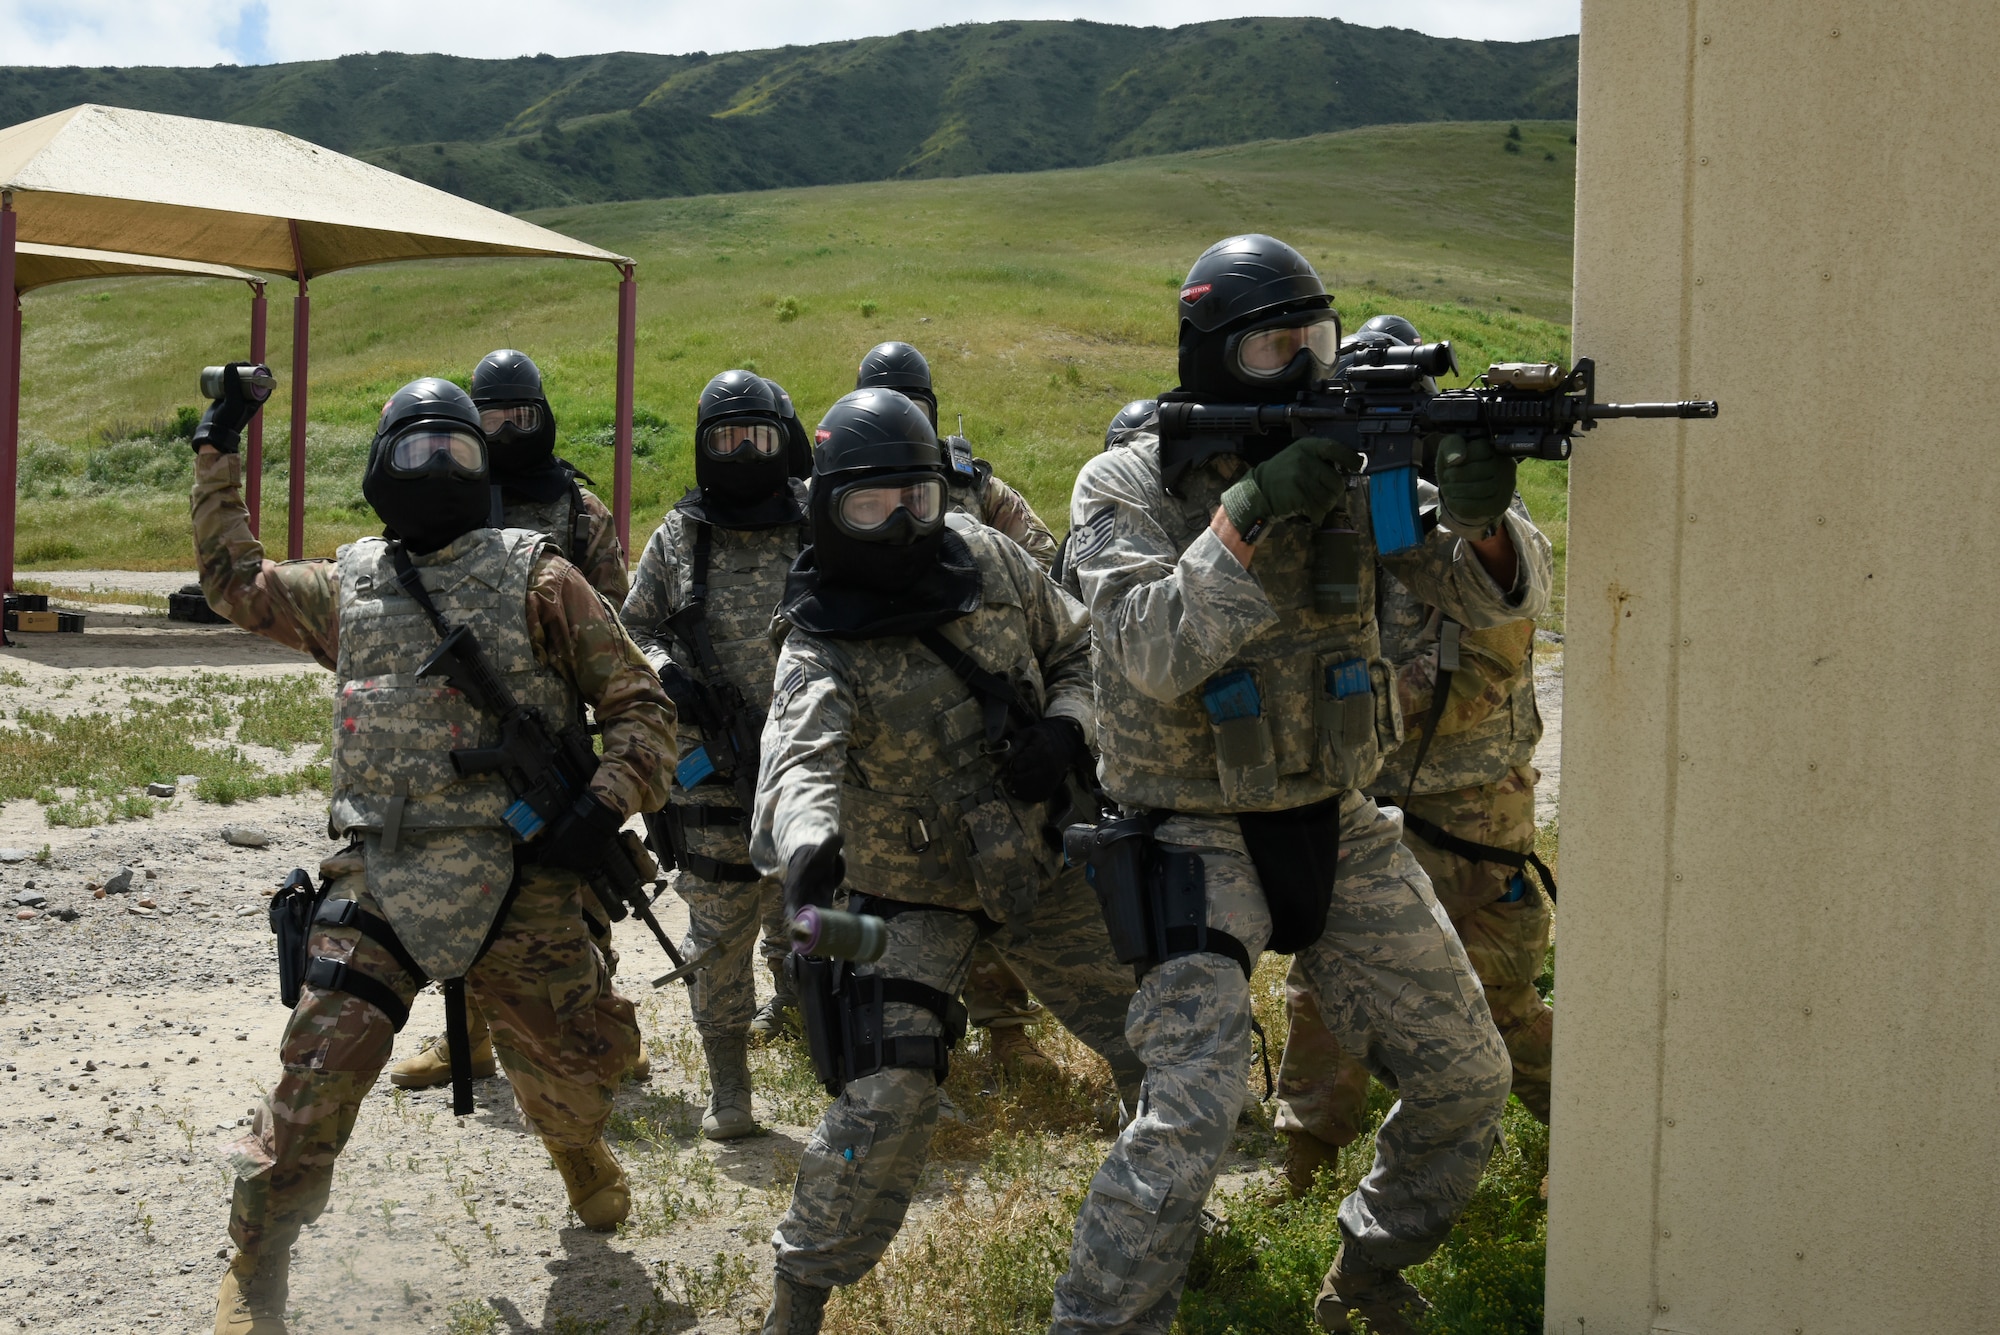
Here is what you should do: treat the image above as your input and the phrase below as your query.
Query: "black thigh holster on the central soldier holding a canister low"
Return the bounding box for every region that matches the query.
[786,955,966,1097]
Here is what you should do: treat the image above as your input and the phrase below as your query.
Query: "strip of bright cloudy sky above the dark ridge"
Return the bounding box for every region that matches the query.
[0,0,1580,66]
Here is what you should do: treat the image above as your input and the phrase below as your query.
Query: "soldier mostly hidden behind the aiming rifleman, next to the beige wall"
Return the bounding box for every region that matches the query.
[1276,488,1556,1195]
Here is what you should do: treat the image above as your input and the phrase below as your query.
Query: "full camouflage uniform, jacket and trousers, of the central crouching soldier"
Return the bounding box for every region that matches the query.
[750,516,1140,1287]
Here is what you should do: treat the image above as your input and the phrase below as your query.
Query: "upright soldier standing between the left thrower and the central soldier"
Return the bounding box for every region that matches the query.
[622,370,810,1141]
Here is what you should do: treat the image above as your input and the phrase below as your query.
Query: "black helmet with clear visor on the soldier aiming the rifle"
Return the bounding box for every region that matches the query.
[1180,234,1340,402]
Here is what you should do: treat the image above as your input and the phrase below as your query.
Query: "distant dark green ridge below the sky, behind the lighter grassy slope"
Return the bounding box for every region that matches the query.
[0,18,1576,210]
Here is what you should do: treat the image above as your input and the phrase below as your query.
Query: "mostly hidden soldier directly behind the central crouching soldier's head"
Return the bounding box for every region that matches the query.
[854,335,1058,1075]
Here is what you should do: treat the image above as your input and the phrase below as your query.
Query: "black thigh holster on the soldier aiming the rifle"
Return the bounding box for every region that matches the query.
[1062,811,1254,981]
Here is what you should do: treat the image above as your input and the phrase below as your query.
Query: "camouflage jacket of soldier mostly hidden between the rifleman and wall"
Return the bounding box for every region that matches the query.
[1368,551,1542,801]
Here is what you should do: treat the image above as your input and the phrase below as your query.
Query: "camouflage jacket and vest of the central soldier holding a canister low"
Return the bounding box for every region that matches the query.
[750,516,1092,921]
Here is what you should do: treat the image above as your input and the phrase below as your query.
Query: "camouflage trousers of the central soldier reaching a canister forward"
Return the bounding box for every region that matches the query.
[772,873,1142,1289]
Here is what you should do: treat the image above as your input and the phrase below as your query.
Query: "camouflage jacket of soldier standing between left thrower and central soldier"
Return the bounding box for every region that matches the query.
[620,482,806,815]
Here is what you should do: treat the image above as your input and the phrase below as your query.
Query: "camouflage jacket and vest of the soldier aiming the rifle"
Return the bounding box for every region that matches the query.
[1066,432,1552,813]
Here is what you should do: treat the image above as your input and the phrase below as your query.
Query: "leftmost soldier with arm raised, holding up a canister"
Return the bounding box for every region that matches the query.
[192,380,674,1335]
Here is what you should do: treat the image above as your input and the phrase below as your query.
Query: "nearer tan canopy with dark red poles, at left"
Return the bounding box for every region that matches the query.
[0,104,638,588]
